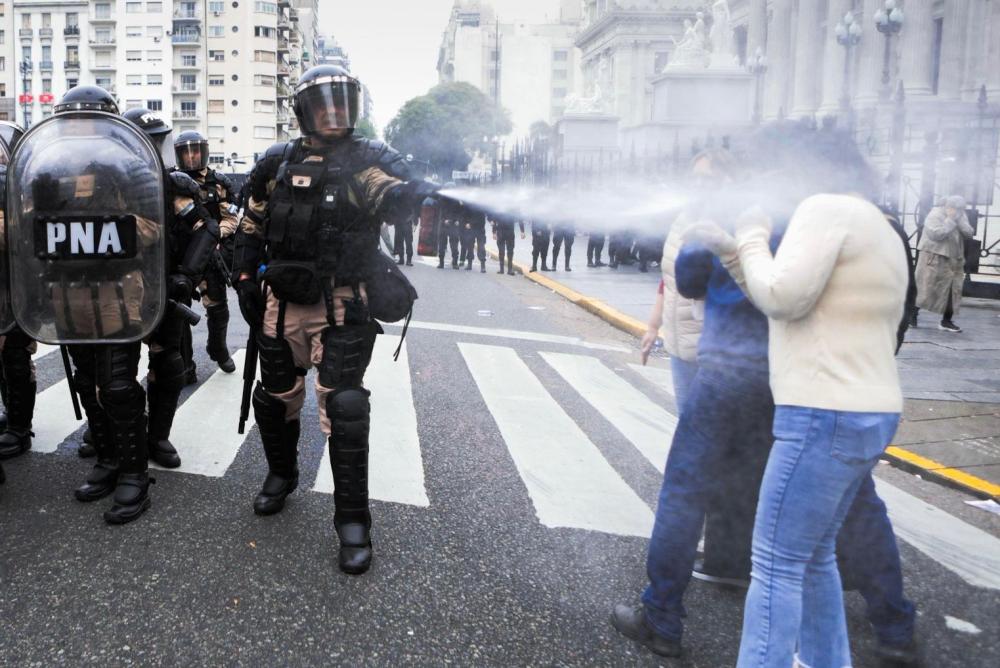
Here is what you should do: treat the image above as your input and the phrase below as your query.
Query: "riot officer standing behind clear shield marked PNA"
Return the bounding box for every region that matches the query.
[8,86,172,524]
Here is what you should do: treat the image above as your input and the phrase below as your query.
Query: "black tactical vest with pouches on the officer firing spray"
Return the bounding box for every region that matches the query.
[264,139,390,304]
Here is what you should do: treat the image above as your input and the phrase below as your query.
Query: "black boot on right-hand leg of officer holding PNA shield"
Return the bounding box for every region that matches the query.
[104,412,152,524]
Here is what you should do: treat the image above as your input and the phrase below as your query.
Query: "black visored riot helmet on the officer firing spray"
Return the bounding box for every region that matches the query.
[292,65,361,138]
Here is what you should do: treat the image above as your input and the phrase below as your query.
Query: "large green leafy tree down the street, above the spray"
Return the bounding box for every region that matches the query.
[385,83,511,174]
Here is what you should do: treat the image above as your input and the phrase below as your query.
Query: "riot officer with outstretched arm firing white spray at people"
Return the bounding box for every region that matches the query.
[234,65,438,574]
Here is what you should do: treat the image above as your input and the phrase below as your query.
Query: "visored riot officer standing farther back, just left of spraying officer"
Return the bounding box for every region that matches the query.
[174,130,238,373]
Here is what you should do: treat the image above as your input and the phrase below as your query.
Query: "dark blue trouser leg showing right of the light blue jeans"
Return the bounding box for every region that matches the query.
[837,473,917,646]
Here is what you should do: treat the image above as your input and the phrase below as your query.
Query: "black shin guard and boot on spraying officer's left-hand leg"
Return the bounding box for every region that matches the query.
[253,383,299,515]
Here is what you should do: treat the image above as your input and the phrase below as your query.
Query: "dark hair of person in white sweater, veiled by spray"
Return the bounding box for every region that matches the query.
[748,121,879,201]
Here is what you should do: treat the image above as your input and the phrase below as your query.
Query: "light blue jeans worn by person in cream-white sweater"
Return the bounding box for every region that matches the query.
[737,406,899,668]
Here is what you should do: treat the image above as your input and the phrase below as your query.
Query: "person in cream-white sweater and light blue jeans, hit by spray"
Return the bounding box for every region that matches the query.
[692,130,908,668]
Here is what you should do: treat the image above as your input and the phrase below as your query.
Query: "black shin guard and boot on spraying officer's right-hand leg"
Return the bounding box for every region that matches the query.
[326,388,372,575]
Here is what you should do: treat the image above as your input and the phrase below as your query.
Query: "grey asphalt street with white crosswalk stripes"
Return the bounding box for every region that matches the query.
[0,252,1000,667]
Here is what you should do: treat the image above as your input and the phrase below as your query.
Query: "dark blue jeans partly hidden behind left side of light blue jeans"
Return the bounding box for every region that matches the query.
[642,364,774,641]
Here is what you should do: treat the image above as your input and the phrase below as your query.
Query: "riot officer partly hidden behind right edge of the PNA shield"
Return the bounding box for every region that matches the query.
[124,107,221,469]
